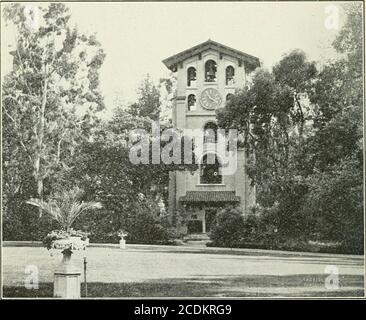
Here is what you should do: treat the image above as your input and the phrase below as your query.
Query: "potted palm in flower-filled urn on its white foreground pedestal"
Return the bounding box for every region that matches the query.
[27,188,102,298]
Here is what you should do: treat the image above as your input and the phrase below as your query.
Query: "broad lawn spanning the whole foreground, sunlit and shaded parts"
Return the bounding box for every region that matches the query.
[3,245,364,297]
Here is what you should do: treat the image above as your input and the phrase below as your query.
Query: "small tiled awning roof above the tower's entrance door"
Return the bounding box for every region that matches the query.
[179,191,240,202]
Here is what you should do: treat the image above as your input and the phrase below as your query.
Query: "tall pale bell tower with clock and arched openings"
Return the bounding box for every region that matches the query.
[163,40,260,235]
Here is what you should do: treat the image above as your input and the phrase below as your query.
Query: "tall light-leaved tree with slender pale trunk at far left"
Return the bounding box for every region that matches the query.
[2,3,104,199]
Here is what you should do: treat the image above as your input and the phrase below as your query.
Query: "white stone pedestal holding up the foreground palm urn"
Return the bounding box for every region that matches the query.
[53,251,81,299]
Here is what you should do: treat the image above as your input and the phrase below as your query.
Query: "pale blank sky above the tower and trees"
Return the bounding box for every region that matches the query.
[1,2,344,116]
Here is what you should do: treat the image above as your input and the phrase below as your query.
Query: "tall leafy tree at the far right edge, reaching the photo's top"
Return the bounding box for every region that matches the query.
[303,4,364,253]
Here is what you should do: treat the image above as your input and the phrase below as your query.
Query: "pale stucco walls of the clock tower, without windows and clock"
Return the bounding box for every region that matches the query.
[170,46,255,218]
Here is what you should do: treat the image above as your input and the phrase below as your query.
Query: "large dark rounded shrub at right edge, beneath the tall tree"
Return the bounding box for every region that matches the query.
[303,156,364,254]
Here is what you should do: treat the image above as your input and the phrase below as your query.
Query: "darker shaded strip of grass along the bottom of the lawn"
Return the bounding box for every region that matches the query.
[3,274,364,298]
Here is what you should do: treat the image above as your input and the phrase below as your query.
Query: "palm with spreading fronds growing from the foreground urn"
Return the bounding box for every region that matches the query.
[27,188,102,232]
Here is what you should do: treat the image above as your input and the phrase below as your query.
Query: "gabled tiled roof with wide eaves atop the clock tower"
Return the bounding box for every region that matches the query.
[163,39,260,70]
